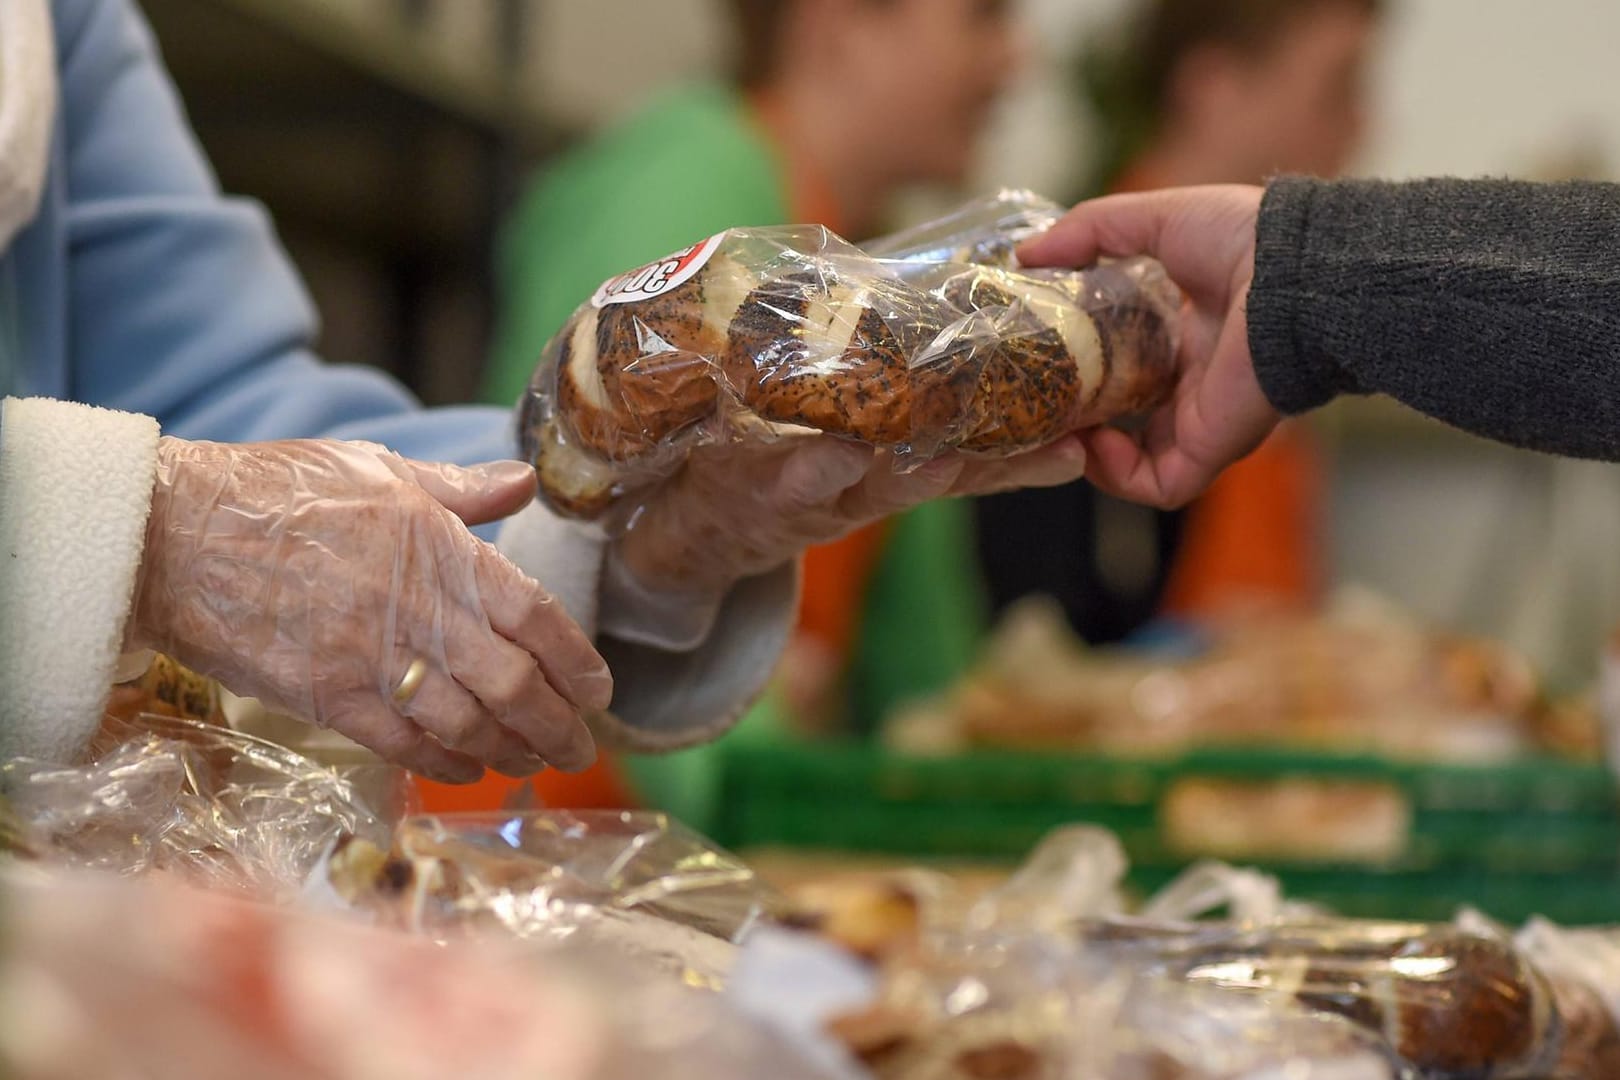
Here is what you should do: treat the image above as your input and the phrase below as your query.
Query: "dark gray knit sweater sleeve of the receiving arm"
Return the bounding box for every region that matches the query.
[1247,178,1620,460]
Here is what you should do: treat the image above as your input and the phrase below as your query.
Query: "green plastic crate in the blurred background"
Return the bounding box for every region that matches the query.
[713,743,1620,923]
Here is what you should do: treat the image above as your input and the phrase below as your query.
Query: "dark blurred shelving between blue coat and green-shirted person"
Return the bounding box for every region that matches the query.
[143,0,557,402]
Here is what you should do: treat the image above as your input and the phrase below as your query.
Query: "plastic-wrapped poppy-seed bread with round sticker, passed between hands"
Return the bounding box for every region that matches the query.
[520,193,1179,525]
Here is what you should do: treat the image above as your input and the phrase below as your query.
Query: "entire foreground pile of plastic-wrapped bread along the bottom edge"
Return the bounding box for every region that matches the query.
[12,721,1620,1080]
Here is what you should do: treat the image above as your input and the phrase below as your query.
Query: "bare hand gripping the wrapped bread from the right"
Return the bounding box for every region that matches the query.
[1019,186,1281,508]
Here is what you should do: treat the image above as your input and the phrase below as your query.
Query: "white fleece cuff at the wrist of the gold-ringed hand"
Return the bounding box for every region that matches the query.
[0,398,159,761]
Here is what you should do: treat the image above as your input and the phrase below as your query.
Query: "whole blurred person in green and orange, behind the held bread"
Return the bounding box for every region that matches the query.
[484,0,1017,826]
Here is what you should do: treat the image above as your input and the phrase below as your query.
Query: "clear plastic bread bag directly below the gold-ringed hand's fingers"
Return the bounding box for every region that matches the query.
[319,811,773,986]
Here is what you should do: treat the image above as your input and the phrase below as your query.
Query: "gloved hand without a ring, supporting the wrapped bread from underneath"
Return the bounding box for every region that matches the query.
[617,436,1085,596]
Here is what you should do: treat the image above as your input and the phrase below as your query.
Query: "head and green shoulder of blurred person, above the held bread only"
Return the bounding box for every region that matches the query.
[484,0,1016,383]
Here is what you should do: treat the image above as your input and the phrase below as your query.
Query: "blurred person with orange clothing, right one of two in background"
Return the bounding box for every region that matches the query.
[977,0,1383,643]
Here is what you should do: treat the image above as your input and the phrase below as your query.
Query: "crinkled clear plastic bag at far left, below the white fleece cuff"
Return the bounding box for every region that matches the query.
[0,716,389,899]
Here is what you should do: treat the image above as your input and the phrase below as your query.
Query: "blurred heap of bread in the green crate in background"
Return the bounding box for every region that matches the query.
[888,589,1581,763]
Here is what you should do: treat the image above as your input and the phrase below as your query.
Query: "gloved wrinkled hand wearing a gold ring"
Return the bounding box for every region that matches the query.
[126,439,612,782]
